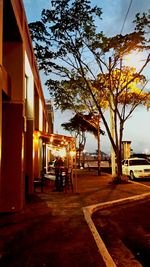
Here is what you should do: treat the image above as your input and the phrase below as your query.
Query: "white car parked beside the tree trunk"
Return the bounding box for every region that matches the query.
[122,158,150,180]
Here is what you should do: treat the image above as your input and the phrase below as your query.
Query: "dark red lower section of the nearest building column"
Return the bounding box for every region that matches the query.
[0,103,24,212]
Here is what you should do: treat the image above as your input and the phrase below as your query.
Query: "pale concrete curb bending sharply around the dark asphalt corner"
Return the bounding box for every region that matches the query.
[83,193,150,267]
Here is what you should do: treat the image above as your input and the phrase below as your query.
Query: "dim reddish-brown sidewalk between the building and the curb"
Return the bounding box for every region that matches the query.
[0,170,150,267]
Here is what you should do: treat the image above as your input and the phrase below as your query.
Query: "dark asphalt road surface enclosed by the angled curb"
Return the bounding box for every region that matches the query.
[93,200,150,267]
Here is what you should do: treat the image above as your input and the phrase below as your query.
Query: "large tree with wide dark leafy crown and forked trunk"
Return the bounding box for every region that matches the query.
[29,0,150,180]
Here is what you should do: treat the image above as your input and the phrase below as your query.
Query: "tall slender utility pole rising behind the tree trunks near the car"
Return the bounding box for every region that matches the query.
[109,57,116,177]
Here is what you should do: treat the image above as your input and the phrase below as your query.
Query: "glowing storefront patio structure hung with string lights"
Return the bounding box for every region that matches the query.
[34,131,76,177]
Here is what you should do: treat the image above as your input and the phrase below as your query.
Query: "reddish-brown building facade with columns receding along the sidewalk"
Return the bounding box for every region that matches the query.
[0,0,53,212]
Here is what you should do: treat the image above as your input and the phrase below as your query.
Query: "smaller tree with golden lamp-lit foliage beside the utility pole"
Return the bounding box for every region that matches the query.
[94,63,149,179]
